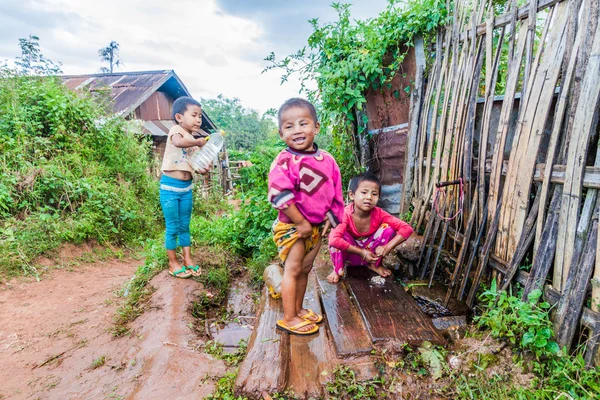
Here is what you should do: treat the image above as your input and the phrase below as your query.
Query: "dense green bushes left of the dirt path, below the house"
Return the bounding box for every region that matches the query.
[0,36,160,282]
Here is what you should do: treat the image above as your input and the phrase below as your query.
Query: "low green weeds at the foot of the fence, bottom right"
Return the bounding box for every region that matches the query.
[453,284,600,399]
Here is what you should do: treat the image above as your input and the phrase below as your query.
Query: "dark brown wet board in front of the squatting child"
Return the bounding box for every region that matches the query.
[346,267,446,346]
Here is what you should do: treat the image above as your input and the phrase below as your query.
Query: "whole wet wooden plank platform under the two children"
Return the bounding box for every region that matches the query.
[235,252,445,398]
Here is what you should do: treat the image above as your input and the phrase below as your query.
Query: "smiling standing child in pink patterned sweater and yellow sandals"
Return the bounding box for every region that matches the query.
[268,98,344,335]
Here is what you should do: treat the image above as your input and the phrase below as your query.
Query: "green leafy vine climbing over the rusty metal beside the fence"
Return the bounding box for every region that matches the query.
[265,0,448,176]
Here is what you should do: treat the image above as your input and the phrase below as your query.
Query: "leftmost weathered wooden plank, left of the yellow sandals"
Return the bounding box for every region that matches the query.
[235,288,290,398]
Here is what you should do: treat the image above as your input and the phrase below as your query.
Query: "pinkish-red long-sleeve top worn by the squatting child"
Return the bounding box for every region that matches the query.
[329,204,413,251]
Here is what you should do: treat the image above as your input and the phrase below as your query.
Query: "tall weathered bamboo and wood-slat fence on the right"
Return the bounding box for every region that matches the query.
[403,0,600,364]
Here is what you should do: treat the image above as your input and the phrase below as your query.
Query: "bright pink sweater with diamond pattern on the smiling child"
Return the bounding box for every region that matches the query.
[268,144,344,227]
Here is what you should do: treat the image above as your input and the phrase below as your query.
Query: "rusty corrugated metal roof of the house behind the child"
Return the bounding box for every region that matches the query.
[61,70,216,130]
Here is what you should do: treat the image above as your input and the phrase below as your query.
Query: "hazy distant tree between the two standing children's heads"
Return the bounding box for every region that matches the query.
[201,95,277,150]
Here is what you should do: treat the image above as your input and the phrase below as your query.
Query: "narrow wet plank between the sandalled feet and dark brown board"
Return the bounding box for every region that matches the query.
[314,256,373,357]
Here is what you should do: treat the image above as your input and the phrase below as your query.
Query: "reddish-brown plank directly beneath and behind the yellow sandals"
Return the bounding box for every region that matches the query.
[286,273,333,398]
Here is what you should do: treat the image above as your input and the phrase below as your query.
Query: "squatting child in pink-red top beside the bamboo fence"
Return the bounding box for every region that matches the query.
[327,172,413,283]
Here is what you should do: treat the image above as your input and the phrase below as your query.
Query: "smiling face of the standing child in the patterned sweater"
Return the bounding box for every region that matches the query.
[279,107,321,151]
